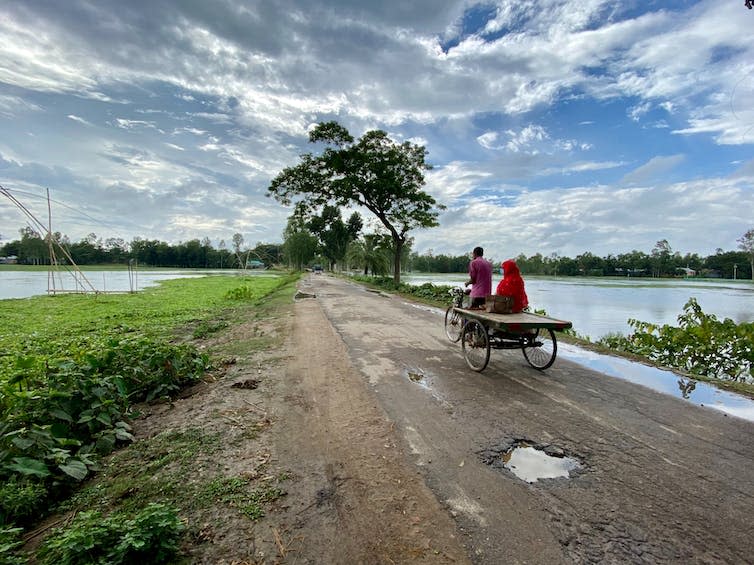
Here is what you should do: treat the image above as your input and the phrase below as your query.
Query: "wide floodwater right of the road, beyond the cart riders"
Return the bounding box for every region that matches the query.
[402,273,754,341]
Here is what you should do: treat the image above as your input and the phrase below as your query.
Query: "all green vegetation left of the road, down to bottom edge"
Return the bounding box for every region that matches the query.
[0,275,298,563]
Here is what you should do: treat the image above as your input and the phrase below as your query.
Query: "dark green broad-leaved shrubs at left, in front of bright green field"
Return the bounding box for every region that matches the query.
[0,334,210,524]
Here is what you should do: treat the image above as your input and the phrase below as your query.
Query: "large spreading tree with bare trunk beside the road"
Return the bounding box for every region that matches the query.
[268,122,444,284]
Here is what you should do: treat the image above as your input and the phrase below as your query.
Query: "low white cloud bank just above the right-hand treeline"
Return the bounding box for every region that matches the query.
[415,175,754,260]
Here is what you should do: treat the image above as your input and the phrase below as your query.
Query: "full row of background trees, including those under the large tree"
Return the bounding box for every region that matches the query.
[0,226,754,279]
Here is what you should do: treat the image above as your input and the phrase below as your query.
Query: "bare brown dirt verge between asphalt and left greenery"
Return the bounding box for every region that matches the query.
[106,278,468,565]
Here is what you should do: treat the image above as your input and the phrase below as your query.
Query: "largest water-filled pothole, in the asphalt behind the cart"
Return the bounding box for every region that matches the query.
[480,439,582,483]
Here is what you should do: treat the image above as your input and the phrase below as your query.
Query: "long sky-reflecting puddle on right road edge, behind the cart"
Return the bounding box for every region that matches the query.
[558,342,754,422]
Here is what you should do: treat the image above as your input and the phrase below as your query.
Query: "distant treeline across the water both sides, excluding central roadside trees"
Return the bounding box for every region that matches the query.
[0,228,752,279]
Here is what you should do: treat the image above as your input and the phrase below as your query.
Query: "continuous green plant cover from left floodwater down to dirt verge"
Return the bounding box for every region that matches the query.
[0,276,296,526]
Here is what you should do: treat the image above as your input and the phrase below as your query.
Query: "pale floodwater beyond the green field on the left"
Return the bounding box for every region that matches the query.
[0,265,274,300]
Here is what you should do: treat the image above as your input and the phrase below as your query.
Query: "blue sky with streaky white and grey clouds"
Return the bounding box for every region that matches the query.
[0,0,754,259]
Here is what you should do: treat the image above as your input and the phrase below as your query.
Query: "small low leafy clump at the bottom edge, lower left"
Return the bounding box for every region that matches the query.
[38,503,184,565]
